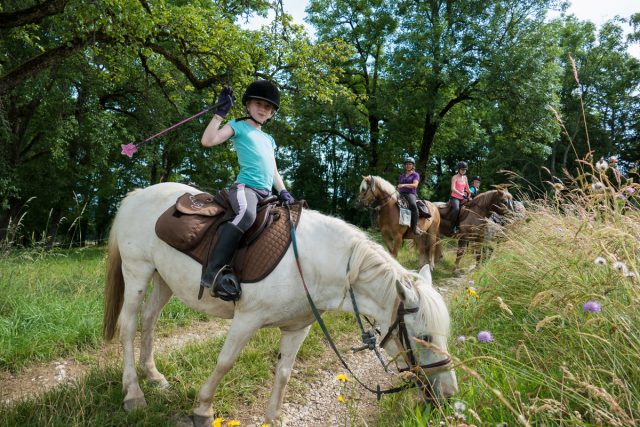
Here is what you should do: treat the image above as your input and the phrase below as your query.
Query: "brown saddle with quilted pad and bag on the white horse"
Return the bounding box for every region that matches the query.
[156,190,306,283]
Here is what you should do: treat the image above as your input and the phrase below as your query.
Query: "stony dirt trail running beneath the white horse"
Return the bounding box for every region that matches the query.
[0,278,466,427]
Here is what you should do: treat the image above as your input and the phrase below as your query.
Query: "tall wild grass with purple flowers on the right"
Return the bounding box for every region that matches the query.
[380,169,640,426]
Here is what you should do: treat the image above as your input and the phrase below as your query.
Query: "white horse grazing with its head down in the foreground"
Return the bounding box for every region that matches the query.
[103,183,457,426]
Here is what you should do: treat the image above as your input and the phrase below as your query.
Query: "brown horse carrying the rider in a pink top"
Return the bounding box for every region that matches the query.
[437,189,514,272]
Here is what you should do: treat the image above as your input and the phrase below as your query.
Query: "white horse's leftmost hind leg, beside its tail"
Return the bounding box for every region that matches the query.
[119,264,153,411]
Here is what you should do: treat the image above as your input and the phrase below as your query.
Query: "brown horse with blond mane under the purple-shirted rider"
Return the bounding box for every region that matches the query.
[358,175,440,270]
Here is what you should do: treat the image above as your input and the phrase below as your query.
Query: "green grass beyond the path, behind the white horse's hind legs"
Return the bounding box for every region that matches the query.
[0,247,204,372]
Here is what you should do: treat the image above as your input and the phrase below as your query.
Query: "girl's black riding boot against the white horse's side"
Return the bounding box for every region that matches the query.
[200,222,244,301]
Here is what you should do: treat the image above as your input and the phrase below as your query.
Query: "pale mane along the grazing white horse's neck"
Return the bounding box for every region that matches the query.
[321,211,449,336]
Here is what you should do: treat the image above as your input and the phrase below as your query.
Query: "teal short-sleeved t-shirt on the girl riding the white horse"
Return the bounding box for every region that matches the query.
[229,120,276,191]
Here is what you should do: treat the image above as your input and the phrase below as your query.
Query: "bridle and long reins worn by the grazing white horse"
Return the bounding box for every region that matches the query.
[287,205,452,400]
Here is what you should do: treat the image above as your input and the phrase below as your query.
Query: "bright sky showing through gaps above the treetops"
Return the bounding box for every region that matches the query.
[244,0,640,58]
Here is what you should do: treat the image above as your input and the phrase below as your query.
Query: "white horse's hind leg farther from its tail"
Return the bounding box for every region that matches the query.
[140,272,173,387]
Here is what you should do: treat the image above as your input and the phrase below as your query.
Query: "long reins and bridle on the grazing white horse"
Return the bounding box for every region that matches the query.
[285,204,451,400]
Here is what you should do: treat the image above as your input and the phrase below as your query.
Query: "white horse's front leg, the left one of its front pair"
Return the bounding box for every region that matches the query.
[193,314,261,425]
